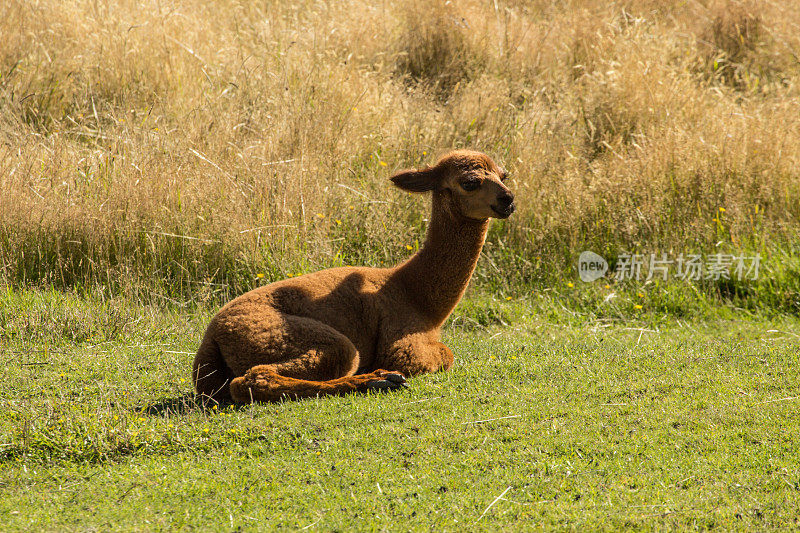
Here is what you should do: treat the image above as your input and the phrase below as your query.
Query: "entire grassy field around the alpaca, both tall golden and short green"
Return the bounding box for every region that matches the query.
[0,0,800,531]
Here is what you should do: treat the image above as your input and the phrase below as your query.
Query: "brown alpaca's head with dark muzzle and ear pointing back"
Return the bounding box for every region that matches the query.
[392,150,516,220]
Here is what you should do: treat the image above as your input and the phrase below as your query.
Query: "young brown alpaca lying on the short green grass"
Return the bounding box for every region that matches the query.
[193,150,514,403]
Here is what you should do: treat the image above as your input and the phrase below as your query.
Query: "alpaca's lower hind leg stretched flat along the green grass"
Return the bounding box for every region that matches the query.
[231,365,405,403]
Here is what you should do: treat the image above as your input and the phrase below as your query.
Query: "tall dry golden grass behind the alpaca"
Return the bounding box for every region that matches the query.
[0,0,800,306]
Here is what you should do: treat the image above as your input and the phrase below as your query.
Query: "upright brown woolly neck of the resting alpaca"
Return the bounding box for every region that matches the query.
[398,192,489,327]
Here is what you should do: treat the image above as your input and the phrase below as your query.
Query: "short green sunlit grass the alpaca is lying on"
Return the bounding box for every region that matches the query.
[0,291,800,531]
